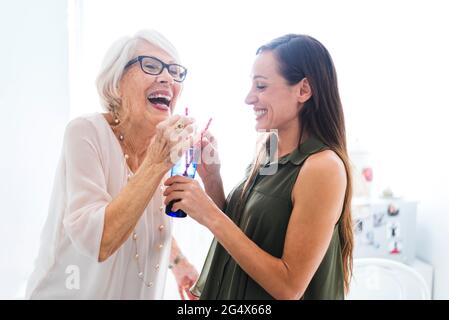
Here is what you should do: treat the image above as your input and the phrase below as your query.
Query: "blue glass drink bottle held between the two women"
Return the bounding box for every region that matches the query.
[165,148,197,218]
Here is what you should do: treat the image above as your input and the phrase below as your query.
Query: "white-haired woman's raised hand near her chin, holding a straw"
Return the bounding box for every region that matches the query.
[146,115,196,170]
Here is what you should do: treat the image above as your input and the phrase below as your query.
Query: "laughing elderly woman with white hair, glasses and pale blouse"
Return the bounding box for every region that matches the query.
[27,31,198,299]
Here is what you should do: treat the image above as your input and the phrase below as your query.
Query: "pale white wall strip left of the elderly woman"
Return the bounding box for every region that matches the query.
[0,0,69,298]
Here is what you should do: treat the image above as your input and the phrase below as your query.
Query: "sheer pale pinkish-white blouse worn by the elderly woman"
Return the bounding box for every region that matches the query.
[26,113,172,299]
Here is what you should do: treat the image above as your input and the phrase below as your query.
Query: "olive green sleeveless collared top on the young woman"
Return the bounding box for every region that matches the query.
[191,137,344,300]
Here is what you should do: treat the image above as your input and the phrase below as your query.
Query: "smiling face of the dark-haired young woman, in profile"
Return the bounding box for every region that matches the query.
[245,51,300,131]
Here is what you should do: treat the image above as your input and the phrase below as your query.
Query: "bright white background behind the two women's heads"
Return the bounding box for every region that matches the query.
[71,0,449,201]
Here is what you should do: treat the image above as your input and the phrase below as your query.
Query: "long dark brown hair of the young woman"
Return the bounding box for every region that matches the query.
[239,34,354,292]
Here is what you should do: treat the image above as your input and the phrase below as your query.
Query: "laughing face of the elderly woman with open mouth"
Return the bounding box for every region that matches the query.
[120,41,182,125]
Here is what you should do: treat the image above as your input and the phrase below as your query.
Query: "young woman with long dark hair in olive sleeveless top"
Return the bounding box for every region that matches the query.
[164,34,353,299]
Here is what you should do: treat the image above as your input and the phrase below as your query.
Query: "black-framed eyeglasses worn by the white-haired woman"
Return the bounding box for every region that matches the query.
[125,56,187,82]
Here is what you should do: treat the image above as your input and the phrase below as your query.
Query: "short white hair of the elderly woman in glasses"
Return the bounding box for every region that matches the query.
[96,30,180,112]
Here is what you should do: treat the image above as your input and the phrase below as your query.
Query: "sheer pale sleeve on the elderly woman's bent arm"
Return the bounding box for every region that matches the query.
[63,118,112,261]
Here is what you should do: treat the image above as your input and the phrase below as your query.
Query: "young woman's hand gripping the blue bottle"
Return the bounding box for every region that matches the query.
[164,176,221,227]
